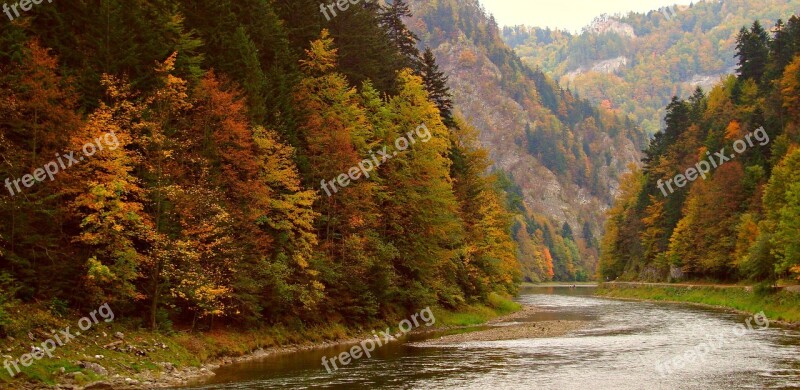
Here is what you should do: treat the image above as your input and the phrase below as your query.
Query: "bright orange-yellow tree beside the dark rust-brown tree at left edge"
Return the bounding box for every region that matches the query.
[68,76,157,303]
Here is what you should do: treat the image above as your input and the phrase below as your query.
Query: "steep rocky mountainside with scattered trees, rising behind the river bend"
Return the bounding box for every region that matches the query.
[408,0,646,281]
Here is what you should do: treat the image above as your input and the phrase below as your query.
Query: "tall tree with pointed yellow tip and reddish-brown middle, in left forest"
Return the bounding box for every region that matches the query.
[294,30,397,321]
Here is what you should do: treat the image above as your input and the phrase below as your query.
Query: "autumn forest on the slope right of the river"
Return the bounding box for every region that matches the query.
[599,16,800,286]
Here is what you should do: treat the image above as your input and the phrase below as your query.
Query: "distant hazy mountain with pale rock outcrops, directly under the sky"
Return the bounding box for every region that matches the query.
[503,0,800,134]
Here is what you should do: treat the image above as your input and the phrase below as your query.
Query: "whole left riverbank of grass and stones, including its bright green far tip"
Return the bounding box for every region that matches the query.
[0,294,520,389]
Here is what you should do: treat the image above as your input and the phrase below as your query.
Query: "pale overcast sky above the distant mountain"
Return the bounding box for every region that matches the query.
[481,0,690,31]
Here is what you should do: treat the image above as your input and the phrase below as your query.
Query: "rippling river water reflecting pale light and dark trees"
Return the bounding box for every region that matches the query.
[181,287,800,389]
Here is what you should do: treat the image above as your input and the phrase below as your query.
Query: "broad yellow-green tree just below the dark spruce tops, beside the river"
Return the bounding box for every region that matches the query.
[380,69,464,305]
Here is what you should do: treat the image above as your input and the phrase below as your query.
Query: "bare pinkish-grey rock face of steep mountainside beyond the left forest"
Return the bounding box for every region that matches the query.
[409,0,641,278]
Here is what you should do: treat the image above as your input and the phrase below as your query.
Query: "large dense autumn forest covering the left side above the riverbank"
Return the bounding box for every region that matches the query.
[0,0,521,335]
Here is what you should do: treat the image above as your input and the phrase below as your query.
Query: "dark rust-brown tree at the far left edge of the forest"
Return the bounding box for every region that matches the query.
[0,40,83,299]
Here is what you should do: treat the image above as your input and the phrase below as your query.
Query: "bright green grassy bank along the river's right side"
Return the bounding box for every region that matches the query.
[596,284,800,323]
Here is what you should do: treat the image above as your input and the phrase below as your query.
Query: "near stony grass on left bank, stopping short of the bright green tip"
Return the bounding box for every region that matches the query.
[0,305,362,389]
